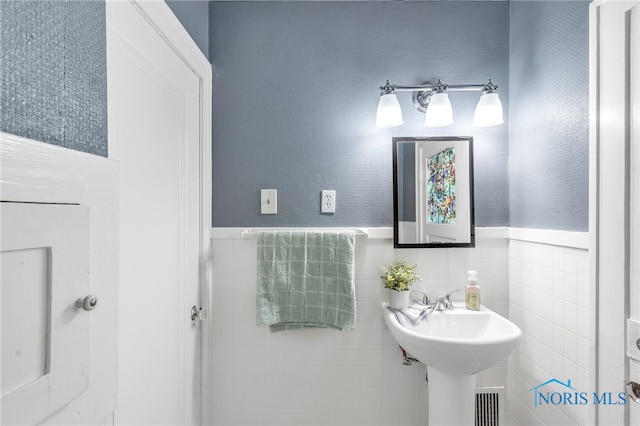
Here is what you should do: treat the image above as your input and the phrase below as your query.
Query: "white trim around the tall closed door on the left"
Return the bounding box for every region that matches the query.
[107,0,212,424]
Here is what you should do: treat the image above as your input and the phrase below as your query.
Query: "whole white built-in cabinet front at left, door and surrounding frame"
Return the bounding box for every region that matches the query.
[0,132,118,426]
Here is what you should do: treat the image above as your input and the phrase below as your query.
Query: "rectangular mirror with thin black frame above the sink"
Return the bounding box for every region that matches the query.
[393,136,475,248]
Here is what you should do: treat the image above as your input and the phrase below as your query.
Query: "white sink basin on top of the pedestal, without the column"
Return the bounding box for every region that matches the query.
[382,303,522,375]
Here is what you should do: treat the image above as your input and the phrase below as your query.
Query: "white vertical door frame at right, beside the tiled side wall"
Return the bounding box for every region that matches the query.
[589,0,640,424]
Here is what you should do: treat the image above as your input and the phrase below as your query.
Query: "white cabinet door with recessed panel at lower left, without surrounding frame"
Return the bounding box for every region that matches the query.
[0,202,90,424]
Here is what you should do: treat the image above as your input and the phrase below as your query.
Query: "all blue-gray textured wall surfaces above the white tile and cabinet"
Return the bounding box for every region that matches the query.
[0,1,588,231]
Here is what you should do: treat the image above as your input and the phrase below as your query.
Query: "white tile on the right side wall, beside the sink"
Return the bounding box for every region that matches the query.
[507,240,595,425]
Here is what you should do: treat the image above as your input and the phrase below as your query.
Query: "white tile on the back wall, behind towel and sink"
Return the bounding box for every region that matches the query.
[210,238,510,426]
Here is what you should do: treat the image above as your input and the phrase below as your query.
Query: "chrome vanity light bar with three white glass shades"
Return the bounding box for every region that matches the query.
[376,79,504,128]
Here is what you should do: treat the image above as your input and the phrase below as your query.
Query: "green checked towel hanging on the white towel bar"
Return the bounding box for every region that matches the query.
[256,231,356,333]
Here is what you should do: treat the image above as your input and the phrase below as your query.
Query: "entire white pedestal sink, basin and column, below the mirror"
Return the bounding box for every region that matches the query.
[382,302,522,426]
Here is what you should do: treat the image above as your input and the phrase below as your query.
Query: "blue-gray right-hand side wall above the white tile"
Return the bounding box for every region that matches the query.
[509,1,589,231]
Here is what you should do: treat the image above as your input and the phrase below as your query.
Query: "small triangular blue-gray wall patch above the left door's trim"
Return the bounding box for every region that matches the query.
[166,0,209,59]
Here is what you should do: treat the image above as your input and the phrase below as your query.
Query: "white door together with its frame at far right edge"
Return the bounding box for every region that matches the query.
[589,0,640,425]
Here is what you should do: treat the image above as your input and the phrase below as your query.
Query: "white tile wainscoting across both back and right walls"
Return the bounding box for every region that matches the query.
[204,228,588,426]
